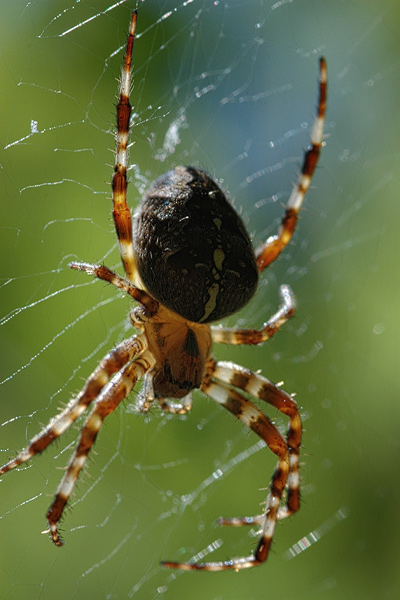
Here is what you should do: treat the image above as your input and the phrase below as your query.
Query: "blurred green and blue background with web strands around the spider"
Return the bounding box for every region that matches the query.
[0,0,400,600]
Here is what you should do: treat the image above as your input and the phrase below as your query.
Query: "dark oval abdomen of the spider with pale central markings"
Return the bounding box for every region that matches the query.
[133,167,258,323]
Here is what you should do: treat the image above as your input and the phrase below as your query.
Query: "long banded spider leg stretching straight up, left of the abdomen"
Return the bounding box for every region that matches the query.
[112,11,137,281]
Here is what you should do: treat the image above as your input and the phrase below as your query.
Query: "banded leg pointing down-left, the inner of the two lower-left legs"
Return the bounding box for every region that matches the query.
[46,352,154,546]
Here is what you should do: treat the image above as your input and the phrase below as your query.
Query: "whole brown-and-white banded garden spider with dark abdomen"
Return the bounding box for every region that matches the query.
[0,11,327,571]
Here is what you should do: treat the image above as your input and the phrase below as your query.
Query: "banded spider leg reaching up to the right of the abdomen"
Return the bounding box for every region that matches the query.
[256,58,327,272]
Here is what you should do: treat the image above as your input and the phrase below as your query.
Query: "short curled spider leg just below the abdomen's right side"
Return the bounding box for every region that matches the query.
[211,285,296,344]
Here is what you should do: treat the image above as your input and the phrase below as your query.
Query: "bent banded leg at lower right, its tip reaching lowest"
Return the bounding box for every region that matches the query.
[162,380,289,571]
